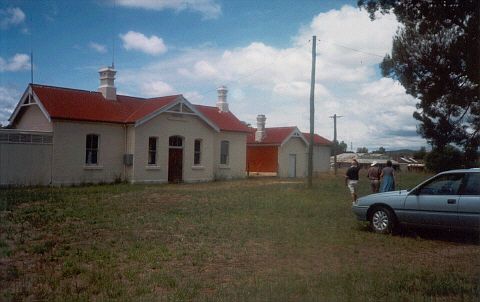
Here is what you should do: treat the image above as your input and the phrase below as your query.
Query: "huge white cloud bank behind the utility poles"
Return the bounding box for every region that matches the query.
[114,6,425,150]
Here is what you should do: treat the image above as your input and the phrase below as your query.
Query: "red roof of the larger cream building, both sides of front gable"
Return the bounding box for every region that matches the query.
[32,85,248,132]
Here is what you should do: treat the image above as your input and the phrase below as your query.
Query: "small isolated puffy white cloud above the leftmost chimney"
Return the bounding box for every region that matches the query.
[120,31,167,55]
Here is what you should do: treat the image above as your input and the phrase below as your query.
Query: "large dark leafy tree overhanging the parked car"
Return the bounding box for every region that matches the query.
[358,0,480,165]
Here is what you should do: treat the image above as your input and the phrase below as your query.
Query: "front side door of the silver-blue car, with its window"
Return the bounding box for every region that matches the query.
[403,173,464,227]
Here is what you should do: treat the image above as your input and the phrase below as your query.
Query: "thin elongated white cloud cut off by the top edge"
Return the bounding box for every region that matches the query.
[117,0,222,19]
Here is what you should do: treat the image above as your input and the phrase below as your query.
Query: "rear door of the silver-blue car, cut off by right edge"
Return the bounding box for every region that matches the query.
[458,172,480,229]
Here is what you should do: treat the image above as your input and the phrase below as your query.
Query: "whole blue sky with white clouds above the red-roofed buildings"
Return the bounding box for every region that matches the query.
[0,0,426,151]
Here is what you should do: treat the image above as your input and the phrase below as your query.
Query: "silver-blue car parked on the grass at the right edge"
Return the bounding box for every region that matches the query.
[352,168,480,233]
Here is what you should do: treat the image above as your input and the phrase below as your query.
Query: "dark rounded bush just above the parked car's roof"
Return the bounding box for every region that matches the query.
[425,146,464,173]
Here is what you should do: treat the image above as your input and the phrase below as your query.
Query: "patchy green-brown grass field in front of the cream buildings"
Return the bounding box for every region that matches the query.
[0,173,480,301]
